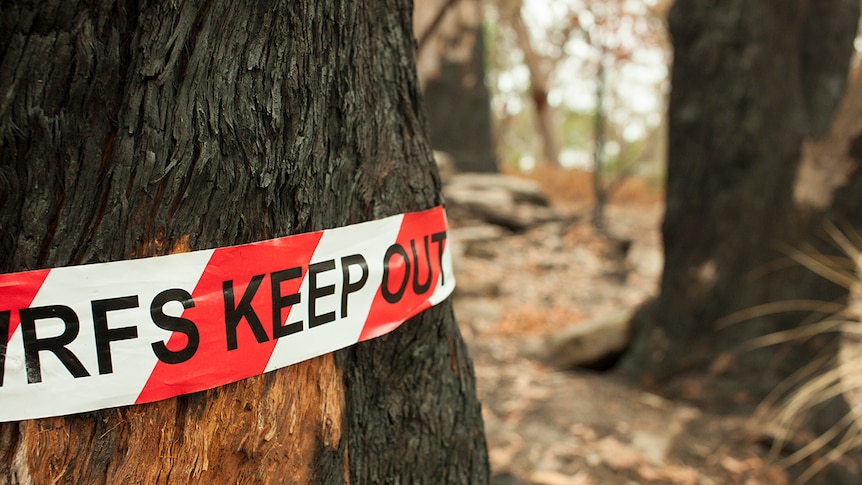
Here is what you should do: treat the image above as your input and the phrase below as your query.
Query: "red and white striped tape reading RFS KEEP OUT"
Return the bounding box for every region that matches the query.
[0,207,455,422]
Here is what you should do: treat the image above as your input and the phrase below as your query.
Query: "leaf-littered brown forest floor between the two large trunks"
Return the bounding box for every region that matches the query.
[452,168,824,485]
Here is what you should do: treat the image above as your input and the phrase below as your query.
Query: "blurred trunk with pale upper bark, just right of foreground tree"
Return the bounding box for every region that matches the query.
[414,0,497,172]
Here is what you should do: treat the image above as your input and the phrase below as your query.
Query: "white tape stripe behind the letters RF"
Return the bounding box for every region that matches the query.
[0,250,213,421]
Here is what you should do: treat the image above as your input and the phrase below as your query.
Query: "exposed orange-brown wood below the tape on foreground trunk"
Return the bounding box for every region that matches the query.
[10,355,349,483]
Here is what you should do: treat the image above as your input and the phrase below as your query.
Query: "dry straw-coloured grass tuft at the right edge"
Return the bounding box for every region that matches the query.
[719,222,862,483]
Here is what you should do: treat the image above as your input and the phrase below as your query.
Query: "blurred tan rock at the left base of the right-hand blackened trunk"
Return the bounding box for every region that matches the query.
[543,308,635,370]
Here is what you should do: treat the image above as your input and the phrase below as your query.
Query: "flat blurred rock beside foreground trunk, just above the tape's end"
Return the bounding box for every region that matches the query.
[443,173,559,231]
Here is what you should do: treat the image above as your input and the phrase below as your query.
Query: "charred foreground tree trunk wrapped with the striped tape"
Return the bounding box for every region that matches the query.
[0,0,489,484]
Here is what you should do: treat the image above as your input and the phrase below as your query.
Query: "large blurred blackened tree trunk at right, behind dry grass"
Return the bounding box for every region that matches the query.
[626,0,859,403]
